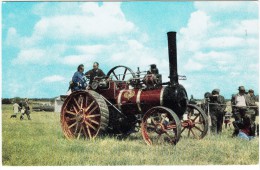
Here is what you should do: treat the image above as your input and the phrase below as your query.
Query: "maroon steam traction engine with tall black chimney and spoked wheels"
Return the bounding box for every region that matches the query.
[61,32,208,145]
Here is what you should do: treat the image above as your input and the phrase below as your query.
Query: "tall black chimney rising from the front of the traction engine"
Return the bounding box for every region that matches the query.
[167,32,179,85]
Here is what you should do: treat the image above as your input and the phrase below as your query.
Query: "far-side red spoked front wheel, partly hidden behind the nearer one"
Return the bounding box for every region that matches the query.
[181,104,208,139]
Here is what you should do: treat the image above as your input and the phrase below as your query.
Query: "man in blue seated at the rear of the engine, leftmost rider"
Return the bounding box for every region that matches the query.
[70,64,87,91]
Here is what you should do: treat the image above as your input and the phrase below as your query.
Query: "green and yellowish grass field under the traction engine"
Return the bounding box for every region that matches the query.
[2,105,259,166]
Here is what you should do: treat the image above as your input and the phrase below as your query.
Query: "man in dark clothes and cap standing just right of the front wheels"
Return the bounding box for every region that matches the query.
[209,89,226,134]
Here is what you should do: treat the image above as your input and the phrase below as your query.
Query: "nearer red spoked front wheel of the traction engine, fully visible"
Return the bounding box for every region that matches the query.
[141,106,181,145]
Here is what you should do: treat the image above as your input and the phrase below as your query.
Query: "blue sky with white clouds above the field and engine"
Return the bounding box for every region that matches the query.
[2,1,259,98]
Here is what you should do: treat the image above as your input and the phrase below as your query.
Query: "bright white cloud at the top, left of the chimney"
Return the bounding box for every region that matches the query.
[33,3,135,40]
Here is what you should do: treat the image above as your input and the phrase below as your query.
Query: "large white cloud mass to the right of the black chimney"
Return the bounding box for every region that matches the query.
[178,2,259,96]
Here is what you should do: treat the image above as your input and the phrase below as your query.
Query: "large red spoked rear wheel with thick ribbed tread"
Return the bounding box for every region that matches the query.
[61,90,109,139]
